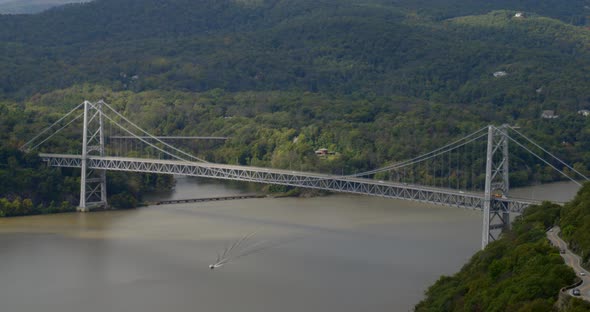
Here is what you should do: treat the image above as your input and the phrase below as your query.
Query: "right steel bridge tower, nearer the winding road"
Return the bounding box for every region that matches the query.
[481,124,510,249]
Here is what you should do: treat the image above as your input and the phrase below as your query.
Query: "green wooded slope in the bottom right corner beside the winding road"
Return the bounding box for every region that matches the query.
[416,183,590,312]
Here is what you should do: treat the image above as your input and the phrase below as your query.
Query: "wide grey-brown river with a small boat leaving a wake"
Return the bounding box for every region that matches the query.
[0,178,584,312]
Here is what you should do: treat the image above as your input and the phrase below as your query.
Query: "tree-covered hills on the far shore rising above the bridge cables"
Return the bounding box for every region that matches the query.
[0,0,590,212]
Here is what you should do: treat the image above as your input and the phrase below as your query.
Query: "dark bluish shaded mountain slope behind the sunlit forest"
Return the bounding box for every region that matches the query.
[0,0,590,109]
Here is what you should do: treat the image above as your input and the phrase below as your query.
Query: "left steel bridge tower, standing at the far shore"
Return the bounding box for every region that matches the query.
[77,100,107,212]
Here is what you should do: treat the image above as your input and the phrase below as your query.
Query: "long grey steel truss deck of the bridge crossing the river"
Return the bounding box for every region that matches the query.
[39,154,537,213]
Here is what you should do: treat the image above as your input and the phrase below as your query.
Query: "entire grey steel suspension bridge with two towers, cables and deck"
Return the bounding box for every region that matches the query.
[22,100,588,248]
